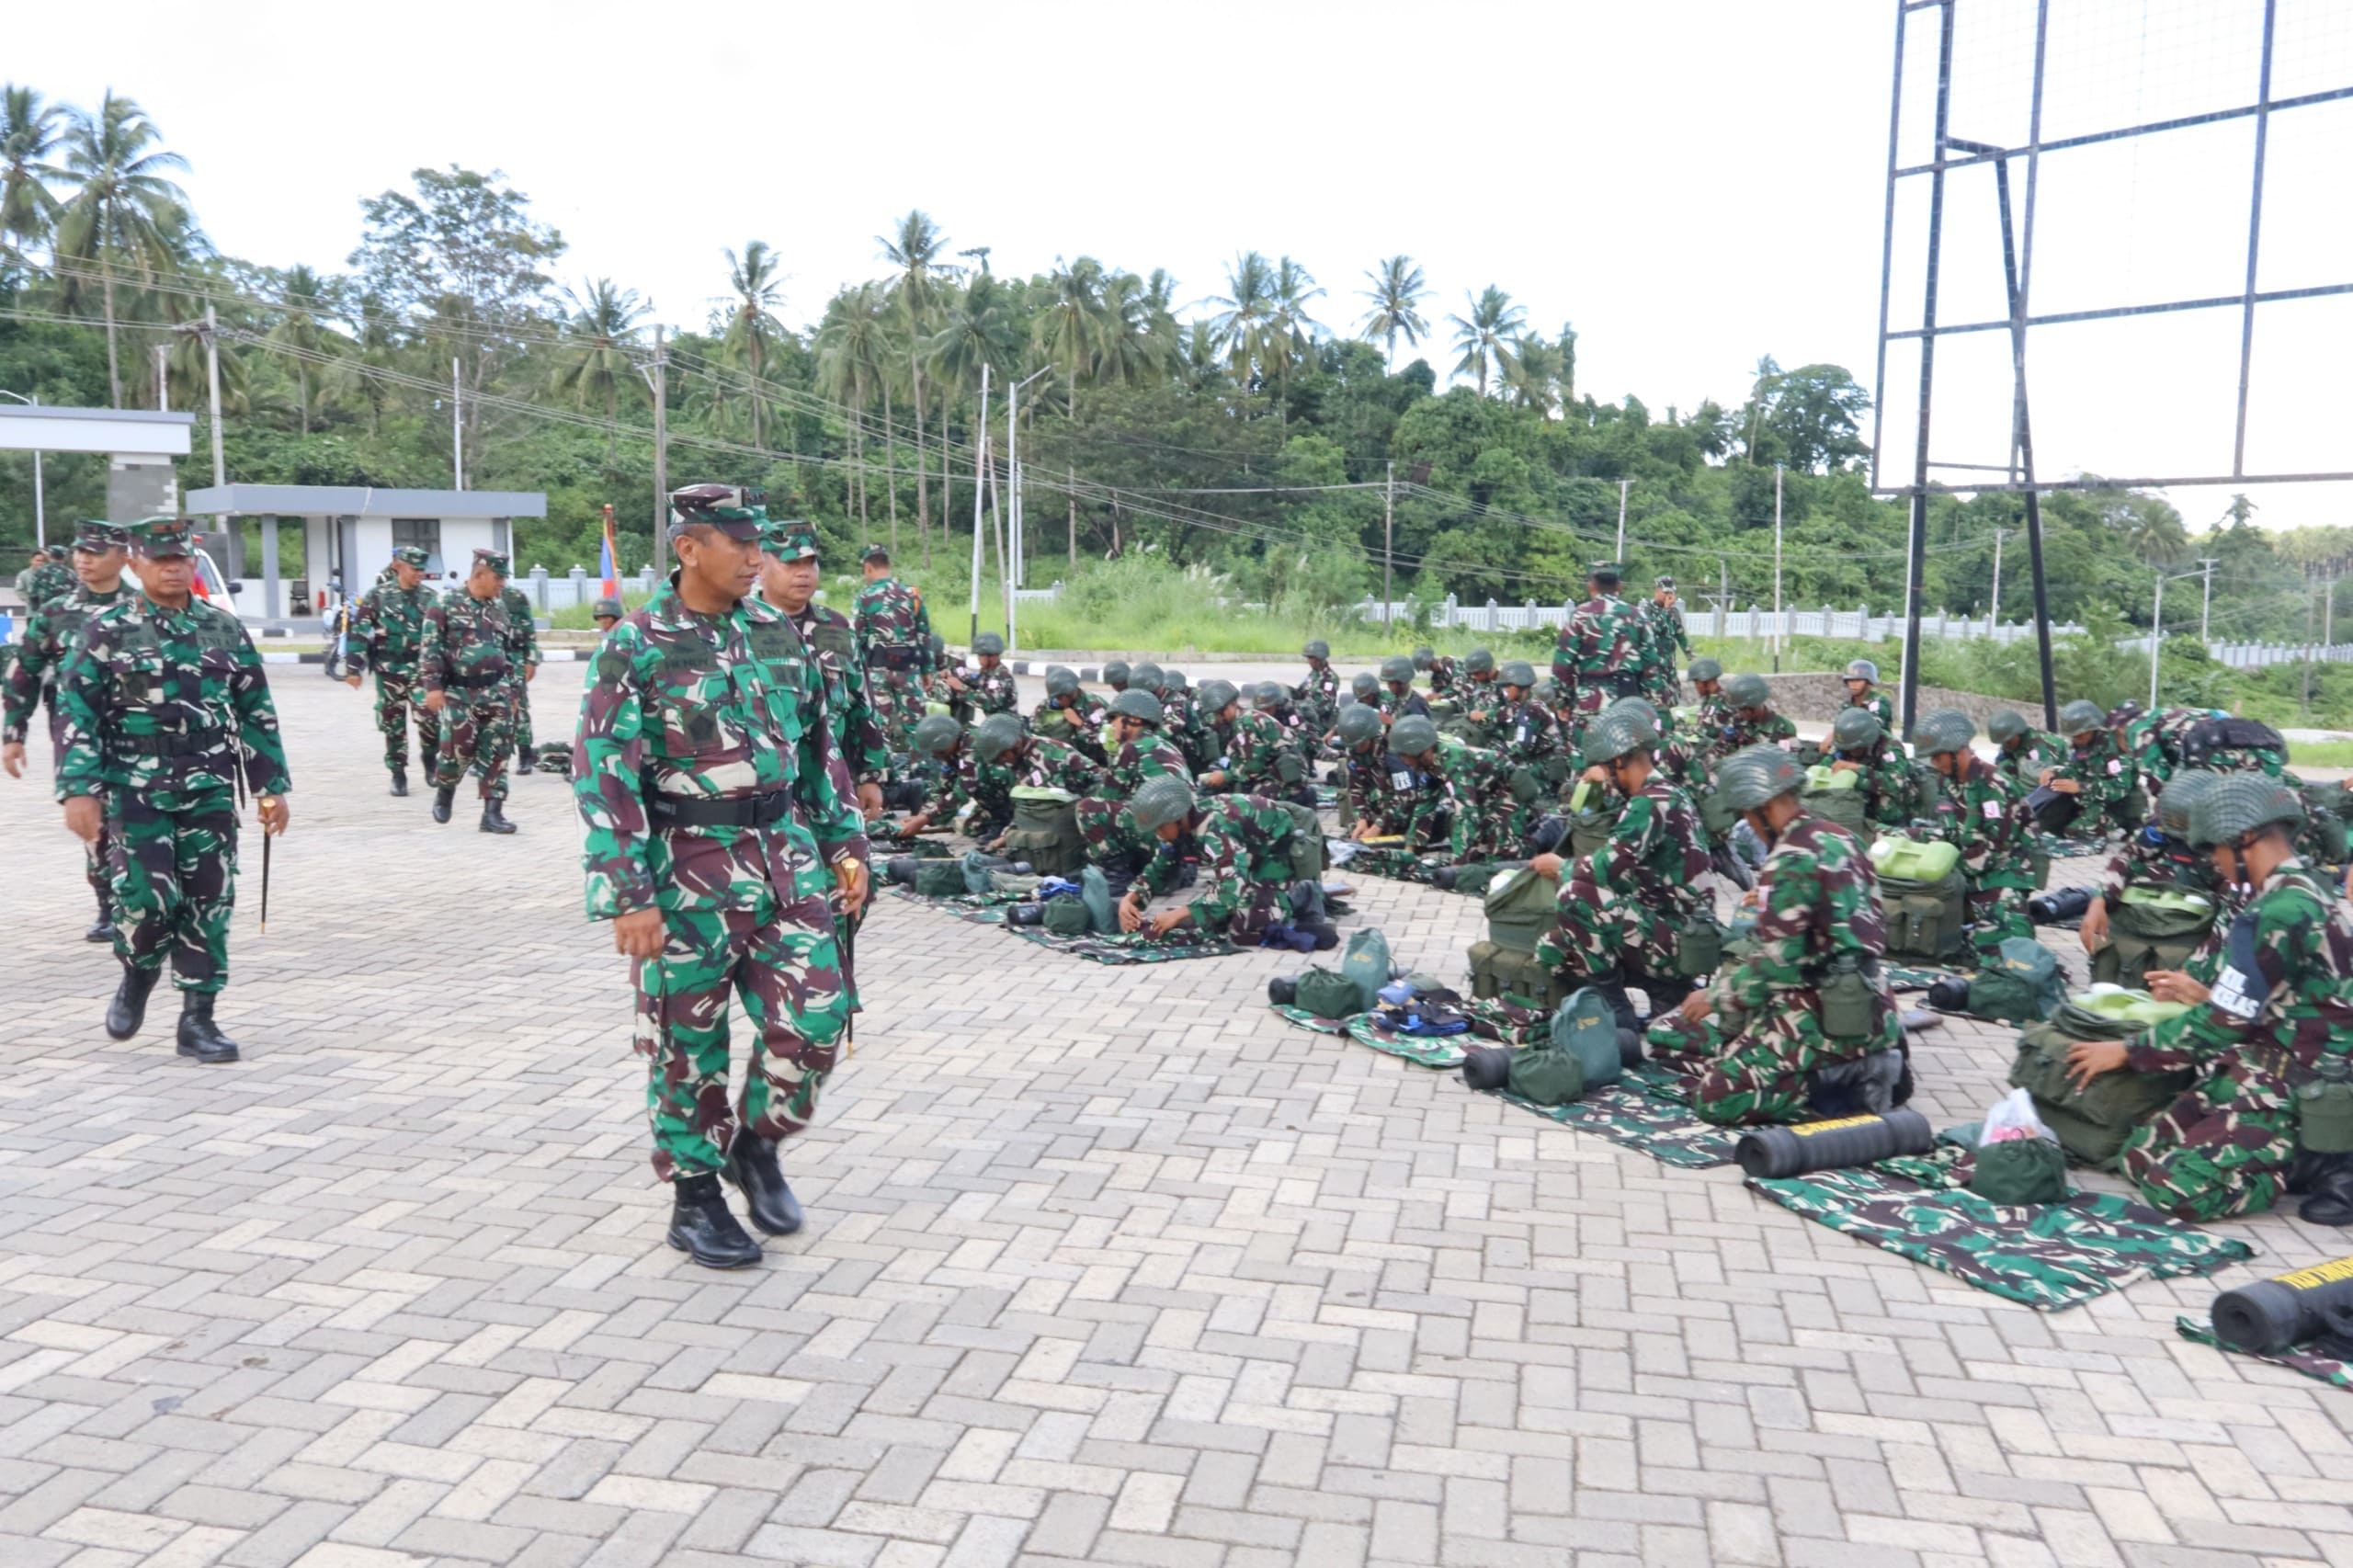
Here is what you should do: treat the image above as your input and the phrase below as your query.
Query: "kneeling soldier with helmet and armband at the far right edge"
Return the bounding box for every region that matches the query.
[2068,775,2353,1224]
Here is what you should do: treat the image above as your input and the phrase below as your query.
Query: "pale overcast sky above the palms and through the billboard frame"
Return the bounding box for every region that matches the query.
[0,0,2353,528]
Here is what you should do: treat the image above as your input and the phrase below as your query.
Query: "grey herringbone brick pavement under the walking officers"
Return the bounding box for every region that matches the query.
[0,666,2353,1568]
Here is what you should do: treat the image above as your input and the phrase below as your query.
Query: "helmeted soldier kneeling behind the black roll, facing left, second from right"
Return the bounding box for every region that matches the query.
[1654,746,1904,1125]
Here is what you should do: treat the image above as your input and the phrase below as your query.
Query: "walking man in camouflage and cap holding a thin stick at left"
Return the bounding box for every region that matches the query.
[56,518,291,1062]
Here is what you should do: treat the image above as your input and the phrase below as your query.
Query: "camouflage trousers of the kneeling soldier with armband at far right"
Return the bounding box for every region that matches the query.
[2118,1055,2297,1220]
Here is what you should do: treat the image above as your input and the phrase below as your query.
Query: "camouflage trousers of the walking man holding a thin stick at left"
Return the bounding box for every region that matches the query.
[106,789,238,991]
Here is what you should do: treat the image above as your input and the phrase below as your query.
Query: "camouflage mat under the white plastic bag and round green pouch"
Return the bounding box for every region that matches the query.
[1748,1170,2254,1312]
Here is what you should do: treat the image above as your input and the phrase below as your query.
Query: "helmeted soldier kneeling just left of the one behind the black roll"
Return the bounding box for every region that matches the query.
[1527,701,1715,1028]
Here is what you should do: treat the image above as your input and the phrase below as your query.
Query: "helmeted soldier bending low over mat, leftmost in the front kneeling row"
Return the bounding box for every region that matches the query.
[1120,775,1339,947]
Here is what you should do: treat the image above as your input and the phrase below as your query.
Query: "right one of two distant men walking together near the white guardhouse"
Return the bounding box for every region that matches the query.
[416,551,534,834]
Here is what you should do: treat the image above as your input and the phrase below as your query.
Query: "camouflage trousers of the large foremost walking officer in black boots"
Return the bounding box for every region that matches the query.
[635,855,849,1182]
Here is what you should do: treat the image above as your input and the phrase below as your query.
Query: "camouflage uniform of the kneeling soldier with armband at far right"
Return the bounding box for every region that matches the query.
[2120,857,2353,1220]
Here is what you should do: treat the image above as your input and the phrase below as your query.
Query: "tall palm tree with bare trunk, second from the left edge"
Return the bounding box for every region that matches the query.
[56,87,188,407]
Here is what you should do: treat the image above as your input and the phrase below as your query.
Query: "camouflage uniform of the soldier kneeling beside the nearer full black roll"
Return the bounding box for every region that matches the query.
[1689,817,1904,1123]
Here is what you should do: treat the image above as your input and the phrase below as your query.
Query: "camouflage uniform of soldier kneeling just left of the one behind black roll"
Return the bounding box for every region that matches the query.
[1537,770,1713,977]
